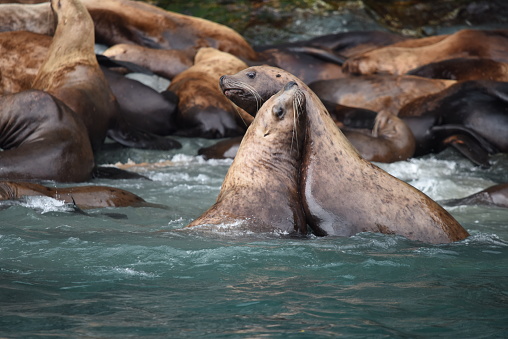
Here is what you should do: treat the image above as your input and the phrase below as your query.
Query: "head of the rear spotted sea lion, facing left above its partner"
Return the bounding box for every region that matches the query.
[219,66,295,116]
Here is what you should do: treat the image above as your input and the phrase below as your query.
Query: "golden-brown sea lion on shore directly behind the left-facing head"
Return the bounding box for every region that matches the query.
[168,47,252,138]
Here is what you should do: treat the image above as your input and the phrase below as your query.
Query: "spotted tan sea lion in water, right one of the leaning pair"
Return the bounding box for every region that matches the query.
[221,66,469,243]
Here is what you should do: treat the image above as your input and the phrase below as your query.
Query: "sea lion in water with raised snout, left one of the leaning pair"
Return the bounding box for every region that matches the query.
[187,82,307,234]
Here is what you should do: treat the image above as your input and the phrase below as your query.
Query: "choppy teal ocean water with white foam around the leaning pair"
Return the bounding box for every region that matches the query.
[0,138,508,338]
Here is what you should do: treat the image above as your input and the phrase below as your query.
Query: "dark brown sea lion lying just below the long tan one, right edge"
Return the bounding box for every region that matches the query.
[407,58,508,81]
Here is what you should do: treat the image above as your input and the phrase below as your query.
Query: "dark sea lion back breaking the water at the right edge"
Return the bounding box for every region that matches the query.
[440,183,508,208]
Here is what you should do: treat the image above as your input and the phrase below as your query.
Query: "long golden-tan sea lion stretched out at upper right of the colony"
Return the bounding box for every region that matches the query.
[343,29,508,74]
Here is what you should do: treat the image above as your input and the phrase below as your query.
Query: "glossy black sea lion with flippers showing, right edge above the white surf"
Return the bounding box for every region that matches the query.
[399,80,508,167]
